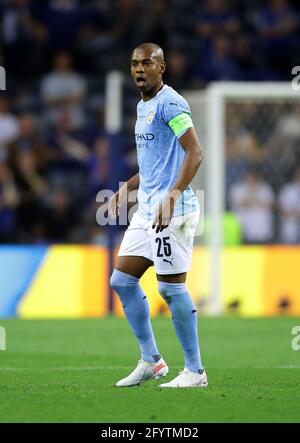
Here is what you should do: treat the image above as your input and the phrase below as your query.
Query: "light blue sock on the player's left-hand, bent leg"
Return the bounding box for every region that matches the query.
[110,269,160,362]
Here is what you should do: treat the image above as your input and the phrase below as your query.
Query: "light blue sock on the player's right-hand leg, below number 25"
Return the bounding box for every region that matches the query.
[158,281,203,372]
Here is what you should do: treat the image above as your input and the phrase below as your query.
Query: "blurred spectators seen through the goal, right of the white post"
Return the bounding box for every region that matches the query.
[226,103,300,244]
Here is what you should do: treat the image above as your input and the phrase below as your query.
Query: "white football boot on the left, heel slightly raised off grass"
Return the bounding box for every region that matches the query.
[116,358,169,387]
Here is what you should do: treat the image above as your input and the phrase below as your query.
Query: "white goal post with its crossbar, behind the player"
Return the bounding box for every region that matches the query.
[188,82,300,315]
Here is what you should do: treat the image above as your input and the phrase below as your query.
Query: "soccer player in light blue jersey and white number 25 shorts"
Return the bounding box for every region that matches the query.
[109,43,208,388]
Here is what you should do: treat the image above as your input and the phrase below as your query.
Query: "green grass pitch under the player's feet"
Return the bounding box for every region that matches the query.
[0,317,300,423]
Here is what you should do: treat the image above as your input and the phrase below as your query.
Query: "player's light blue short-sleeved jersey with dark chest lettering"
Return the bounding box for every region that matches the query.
[135,85,199,220]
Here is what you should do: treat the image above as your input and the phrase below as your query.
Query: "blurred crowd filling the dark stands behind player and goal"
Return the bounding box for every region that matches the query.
[0,0,300,243]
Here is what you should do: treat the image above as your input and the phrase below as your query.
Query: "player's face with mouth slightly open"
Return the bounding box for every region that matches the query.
[131,49,165,93]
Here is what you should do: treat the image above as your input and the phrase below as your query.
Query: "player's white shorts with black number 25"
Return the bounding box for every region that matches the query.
[118,211,199,275]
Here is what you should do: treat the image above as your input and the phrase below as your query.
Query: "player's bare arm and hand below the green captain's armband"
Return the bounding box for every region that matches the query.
[152,127,203,232]
